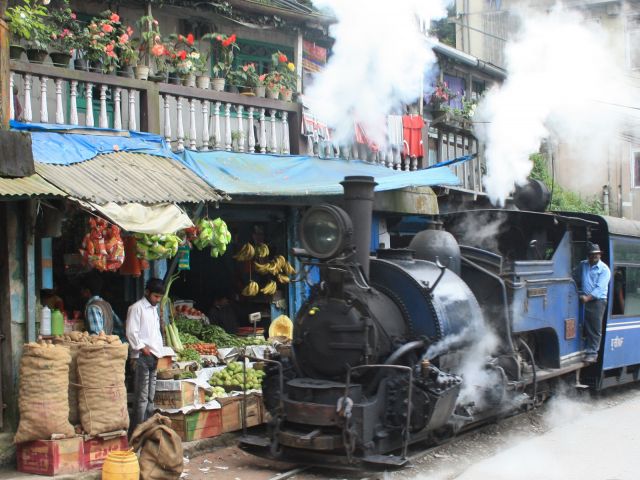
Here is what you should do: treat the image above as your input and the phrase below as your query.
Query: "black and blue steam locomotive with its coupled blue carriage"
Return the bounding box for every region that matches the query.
[241,177,640,468]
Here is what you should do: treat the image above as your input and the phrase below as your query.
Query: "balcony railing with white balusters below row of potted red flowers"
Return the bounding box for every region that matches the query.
[10,60,301,155]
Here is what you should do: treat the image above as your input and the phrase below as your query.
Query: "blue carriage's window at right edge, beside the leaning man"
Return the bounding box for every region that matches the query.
[611,239,640,316]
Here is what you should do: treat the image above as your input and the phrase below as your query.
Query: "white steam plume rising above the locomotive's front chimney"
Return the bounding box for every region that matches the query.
[305,0,450,146]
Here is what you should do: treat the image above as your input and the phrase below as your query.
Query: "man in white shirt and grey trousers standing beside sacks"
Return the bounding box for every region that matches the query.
[127,278,164,432]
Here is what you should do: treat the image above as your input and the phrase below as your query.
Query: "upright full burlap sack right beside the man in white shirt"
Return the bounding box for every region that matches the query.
[77,343,129,435]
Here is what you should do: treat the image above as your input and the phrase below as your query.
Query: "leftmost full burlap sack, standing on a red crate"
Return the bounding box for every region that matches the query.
[15,343,75,443]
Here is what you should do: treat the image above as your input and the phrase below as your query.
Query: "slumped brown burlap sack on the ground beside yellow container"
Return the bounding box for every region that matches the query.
[129,413,184,480]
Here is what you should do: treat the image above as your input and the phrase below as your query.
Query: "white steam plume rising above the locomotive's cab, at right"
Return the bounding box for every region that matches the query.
[475,5,638,205]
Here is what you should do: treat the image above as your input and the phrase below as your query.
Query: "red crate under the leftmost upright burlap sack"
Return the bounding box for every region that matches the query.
[16,437,83,476]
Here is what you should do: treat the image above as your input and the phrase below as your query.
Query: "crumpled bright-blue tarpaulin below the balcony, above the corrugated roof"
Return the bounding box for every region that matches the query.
[11,120,177,165]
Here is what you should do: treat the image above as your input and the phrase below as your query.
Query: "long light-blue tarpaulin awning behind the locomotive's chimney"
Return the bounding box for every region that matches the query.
[182,150,460,196]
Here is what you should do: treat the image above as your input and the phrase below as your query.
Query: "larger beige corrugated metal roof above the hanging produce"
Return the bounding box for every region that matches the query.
[36,152,226,204]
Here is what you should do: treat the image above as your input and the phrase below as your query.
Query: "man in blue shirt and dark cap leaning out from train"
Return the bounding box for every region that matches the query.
[580,243,611,363]
